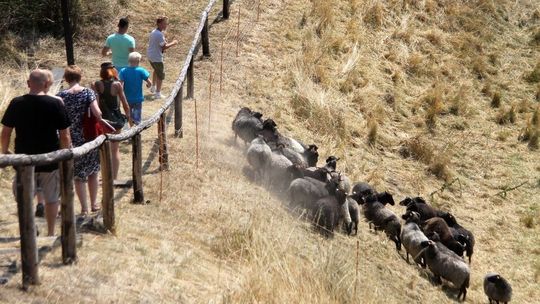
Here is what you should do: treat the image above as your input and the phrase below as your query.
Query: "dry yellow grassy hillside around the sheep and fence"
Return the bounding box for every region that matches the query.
[0,0,540,303]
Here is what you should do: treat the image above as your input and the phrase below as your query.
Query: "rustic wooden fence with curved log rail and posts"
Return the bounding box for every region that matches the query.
[0,0,230,290]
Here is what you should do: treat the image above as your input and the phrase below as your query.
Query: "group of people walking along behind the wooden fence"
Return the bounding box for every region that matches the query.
[0,16,177,236]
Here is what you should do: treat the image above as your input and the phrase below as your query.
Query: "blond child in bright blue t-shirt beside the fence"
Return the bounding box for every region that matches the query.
[119,52,152,125]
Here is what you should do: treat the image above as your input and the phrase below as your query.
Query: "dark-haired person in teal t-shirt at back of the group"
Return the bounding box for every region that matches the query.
[101,18,135,72]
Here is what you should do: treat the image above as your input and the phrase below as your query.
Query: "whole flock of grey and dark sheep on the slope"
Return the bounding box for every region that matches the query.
[232,107,512,303]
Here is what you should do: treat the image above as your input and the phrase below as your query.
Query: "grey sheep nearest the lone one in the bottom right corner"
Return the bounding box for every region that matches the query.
[415,241,471,301]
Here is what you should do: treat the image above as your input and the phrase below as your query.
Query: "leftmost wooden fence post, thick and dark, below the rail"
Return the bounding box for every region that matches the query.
[15,166,39,290]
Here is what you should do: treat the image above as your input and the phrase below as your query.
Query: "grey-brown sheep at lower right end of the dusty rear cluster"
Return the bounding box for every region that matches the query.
[315,183,350,237]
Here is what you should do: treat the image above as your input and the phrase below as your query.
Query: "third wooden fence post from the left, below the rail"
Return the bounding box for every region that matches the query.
[99,140,115,233]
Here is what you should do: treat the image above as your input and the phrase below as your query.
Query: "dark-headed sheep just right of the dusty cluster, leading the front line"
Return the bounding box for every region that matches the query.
[359,192,401,251]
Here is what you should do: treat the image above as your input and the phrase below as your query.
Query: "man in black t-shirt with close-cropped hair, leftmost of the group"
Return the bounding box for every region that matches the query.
[0,69,71,236]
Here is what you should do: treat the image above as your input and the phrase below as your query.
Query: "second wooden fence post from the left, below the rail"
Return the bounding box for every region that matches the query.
[60,159,77,264]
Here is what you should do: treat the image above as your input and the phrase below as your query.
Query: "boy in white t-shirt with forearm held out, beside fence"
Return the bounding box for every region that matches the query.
[147,16,178,99]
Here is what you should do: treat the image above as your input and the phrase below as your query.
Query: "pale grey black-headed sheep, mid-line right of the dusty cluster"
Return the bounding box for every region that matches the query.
[401,211,428,268]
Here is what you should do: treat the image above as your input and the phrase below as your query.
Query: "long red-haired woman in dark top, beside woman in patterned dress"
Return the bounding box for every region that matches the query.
[94,62,131,179]
